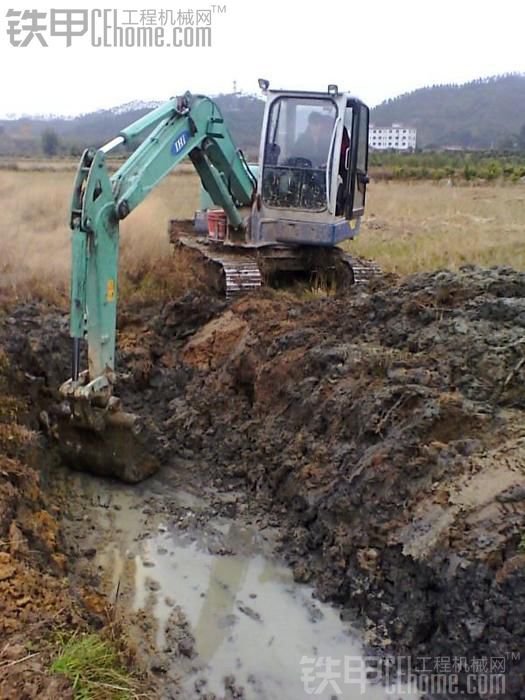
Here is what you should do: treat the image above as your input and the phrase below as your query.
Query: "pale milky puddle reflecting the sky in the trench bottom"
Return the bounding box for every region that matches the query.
[87,493,417,700]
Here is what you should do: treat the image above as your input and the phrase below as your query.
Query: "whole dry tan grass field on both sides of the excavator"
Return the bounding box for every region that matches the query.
[0,170,525,298]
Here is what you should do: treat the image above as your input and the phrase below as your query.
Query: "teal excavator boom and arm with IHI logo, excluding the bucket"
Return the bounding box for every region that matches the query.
[57,93,256,476]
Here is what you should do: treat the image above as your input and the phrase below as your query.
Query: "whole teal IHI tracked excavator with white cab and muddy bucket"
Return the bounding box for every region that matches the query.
[58,80,376,482]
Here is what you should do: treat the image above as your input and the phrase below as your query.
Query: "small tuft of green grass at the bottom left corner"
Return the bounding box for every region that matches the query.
[51,632,138,700]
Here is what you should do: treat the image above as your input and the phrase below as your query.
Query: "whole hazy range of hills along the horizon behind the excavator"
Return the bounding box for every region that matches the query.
[0,74,525,158]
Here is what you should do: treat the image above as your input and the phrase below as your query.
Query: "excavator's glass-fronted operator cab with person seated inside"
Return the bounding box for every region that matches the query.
[252,86,369,246]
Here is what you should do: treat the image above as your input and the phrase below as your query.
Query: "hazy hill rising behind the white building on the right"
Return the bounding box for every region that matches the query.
[371,74,525,149]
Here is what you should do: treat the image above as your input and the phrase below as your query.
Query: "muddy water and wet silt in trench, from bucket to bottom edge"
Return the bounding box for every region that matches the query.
[50,464,417,700]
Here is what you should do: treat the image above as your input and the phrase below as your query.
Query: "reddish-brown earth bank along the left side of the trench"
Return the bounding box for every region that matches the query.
[0,338,104,699]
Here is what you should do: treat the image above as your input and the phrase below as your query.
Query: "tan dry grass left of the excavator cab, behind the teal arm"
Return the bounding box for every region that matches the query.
[0,171,198,303]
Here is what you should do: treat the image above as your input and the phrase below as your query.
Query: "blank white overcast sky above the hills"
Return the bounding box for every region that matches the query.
[0,0,525,115]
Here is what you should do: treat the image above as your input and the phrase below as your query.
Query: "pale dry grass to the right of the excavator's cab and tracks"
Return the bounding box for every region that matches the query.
[349,183,525,274]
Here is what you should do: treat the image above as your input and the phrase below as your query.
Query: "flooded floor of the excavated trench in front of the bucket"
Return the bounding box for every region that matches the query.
[45,461,419,700]
